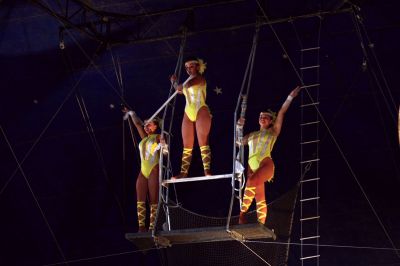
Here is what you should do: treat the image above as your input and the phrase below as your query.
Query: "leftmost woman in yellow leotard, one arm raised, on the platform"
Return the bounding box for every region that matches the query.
[123,108,166,232]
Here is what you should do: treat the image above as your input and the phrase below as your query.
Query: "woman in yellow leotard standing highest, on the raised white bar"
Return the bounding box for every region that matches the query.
[170,58,211,178]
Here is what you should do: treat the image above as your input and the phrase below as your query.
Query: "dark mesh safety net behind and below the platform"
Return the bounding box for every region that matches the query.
[152,187,297,266]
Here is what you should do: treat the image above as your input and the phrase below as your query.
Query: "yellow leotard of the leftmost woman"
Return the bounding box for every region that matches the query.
[139,134,159,178]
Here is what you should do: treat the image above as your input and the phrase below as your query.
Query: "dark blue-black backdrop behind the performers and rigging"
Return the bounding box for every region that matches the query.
[0,0,400,265]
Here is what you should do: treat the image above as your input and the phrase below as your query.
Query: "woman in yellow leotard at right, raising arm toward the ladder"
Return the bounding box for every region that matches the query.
[237,87,300,224]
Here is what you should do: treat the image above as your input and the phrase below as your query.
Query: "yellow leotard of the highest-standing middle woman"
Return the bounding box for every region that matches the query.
[183,83,208,122]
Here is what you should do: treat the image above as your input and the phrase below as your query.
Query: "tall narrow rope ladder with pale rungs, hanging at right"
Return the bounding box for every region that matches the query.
[299,17,321,266]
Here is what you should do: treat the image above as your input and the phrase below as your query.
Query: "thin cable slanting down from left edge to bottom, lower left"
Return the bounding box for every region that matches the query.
[0,125,68,265]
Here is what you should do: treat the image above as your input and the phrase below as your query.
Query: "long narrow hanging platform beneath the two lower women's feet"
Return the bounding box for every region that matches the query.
[125,223,276,249]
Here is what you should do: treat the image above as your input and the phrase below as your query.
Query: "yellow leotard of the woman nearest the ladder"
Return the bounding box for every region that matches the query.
[247,129,277,172]
